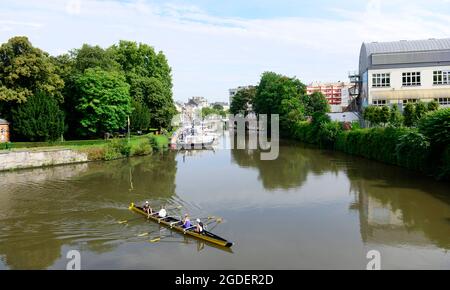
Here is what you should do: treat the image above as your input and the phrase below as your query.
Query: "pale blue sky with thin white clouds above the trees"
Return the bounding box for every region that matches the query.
[0,0,450,102]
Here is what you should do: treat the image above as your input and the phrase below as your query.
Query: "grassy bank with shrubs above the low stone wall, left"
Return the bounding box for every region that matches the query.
[0,134,169,161]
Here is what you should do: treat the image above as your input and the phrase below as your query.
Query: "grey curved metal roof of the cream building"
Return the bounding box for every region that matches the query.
[359,38,450,73]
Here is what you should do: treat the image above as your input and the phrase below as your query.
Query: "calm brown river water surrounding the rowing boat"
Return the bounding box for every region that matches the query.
[0,137,450,269]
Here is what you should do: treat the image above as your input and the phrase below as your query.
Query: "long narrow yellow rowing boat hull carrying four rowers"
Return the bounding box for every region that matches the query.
[128,203,233,248]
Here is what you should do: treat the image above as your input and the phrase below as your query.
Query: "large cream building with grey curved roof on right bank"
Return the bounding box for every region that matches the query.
[357,38,450,108]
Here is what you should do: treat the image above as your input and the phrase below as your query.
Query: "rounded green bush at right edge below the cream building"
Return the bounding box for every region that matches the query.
[419,108,450,146]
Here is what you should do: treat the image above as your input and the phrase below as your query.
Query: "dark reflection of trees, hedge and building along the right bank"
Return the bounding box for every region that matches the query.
[232,136,450,249]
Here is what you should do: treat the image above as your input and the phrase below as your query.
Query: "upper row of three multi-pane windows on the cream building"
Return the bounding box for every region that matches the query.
[372,70,450,88]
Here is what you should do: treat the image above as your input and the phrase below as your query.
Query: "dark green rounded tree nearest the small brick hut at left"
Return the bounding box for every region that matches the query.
[12,92,64,141]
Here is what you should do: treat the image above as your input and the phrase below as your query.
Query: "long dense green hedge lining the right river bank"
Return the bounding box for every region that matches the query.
[293,109,450,180]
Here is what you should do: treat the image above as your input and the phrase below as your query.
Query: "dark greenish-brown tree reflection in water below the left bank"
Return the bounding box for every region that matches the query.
[0,153,177,269]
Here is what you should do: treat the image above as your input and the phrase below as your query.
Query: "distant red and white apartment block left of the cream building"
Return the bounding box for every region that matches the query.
[306,82,351,113]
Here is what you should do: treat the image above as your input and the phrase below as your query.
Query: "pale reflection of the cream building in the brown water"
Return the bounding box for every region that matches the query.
[356,193,430,246]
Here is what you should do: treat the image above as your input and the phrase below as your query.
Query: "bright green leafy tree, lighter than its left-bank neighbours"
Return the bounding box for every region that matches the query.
[76,68,131,136]
